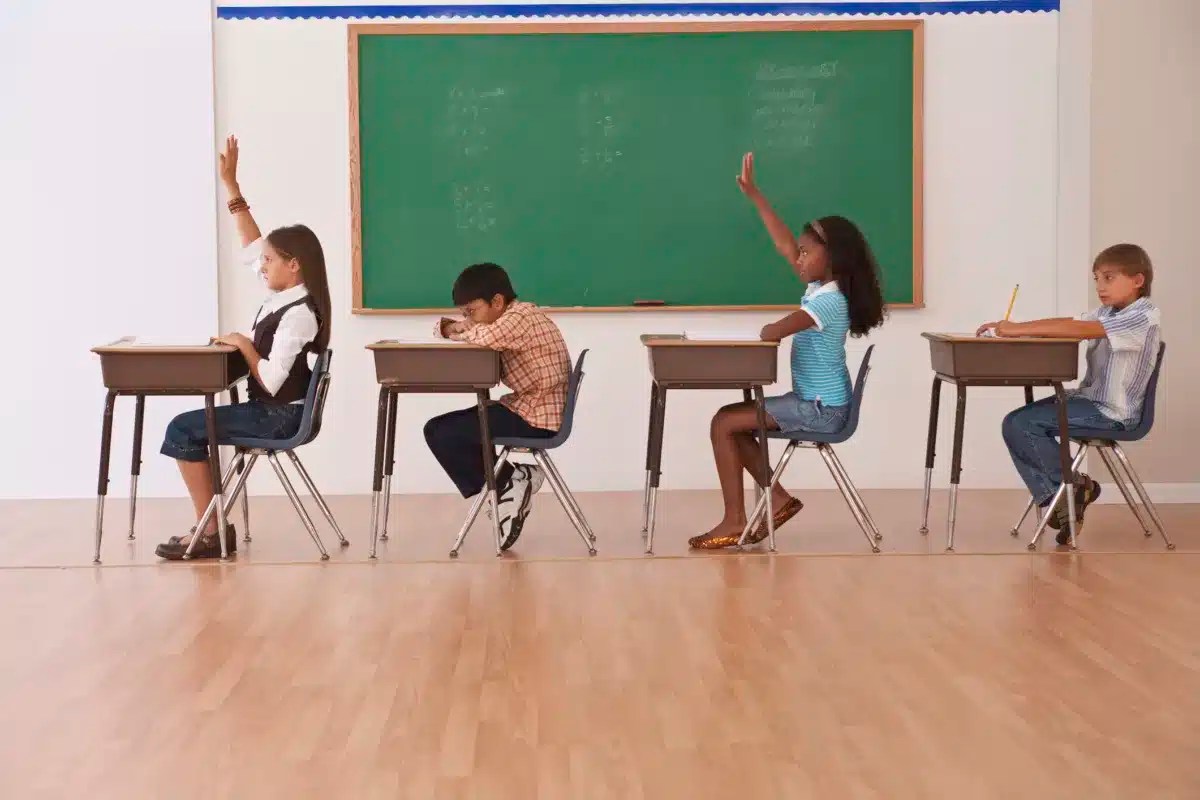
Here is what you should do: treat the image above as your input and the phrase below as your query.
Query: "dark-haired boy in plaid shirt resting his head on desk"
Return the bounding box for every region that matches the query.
[425,264,571,549]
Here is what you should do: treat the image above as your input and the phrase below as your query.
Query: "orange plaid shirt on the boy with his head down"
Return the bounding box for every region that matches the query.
[437,302,571,431]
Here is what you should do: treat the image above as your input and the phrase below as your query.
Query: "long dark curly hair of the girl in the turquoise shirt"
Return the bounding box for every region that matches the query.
[804,217,886,336]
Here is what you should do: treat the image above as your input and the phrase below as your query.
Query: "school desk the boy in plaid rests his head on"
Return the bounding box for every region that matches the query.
[367,339,500,558]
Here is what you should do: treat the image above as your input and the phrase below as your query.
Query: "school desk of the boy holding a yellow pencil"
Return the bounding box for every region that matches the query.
[920,333,1079,551]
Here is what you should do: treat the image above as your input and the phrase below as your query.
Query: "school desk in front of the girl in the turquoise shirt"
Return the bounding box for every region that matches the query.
[642,335,779,554]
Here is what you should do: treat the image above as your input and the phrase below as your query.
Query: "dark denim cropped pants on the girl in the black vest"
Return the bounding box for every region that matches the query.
[158,402,304,461]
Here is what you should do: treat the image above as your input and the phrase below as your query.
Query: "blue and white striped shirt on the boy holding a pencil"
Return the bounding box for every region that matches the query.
[1073,297,1162,426]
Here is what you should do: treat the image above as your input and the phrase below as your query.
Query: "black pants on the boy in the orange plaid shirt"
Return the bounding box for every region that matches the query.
[425,403,554,498]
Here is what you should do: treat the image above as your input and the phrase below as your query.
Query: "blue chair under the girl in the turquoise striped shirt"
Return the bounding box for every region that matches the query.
[738,344,883,553]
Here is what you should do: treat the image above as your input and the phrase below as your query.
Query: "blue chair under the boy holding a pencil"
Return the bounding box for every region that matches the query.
[1009,342,1175,551]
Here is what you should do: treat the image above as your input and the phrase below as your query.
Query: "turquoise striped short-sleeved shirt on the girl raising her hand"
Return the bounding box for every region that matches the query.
[792,281,850,407]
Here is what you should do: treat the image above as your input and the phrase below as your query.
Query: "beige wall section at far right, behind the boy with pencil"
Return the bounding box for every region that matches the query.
[1092,0,1200,489]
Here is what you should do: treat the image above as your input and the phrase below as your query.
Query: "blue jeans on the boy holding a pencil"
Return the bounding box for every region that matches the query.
[1001,397,1124,506]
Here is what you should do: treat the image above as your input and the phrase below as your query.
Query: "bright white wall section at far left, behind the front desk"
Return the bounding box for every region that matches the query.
[0,0,217,498]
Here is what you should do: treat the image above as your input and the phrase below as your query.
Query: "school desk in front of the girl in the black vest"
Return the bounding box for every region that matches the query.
[91,337,250,564]
